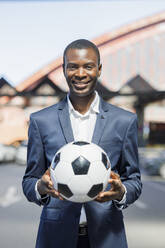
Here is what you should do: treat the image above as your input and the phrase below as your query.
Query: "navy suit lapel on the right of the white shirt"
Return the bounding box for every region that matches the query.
[92,98,108,144]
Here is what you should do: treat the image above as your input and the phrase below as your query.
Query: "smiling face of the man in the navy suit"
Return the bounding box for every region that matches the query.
[64,48,101,97]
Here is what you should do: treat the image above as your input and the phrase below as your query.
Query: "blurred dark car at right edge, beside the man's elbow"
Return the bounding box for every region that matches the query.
[139,148,165,178]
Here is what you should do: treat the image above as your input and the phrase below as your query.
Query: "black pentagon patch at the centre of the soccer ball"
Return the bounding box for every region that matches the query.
[72,156,90,175]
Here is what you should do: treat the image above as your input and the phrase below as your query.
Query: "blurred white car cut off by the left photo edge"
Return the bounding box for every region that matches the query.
[0,144,16,163]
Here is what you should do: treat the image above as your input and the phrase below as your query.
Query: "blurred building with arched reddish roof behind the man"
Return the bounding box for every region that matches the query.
[0,12,165,146]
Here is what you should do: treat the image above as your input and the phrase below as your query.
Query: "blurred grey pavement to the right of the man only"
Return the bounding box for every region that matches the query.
[123,173,165,248]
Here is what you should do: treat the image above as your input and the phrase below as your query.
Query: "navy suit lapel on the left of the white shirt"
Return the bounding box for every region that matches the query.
[58,98,74,143]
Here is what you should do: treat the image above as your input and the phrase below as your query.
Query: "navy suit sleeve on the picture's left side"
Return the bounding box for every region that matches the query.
[22,116,47,205]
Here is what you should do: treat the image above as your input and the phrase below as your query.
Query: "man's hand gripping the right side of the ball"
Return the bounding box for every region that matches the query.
[95,171,125,202]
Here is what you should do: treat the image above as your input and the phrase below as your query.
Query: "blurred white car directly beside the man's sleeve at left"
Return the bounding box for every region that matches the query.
[15,140,27,165]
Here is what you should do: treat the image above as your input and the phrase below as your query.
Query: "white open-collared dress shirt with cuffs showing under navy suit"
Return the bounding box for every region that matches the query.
[35,91,126,217]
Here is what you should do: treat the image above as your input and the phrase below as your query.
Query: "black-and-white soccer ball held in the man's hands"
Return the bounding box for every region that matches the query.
[50,141,111,203]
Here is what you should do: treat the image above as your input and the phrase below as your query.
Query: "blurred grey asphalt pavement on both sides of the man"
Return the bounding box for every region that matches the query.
[0,164,165,248]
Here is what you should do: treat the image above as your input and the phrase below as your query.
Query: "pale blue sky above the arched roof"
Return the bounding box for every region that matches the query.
[0,0,165,85]
